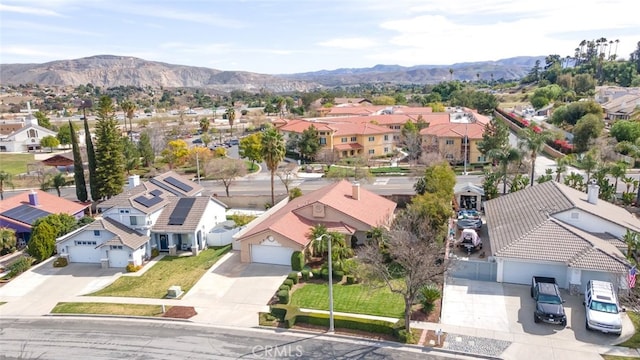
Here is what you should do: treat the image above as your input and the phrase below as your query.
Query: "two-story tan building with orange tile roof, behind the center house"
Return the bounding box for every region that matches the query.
[278,119,395,159]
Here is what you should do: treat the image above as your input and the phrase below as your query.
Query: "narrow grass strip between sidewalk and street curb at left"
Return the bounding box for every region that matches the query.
[51,302,170,316]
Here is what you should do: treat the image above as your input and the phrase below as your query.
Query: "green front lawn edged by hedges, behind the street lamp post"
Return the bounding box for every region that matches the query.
[291,283,404,318]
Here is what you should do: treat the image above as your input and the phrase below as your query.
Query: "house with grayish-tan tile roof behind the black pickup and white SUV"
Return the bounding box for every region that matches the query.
[484,181,640,294]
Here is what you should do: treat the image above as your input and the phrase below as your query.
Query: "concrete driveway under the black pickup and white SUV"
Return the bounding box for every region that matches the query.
[441,278,634,345]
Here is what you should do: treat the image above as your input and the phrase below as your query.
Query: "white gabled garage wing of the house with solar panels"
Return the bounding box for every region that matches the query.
[56,217,150,268]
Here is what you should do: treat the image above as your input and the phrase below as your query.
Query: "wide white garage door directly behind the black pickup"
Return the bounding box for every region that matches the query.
[502,261,568,289]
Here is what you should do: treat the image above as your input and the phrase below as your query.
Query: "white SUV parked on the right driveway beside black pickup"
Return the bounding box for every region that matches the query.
[583,280,624,336]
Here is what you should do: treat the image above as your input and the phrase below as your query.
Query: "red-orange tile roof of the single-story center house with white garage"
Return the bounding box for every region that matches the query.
[239,180,396,246]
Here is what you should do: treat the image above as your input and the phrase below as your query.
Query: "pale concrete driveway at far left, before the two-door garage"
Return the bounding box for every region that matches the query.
[0,258,122,316]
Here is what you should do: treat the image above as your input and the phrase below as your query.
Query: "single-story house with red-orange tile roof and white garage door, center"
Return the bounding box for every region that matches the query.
[234,180,396,265]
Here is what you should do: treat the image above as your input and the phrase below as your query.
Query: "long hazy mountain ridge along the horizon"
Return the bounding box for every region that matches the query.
[0,55,544,92]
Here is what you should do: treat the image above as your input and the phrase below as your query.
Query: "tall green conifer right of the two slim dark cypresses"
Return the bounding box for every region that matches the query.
[96,95,125,199]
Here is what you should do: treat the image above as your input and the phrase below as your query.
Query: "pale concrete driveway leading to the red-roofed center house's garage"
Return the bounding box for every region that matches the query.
[180,251,291,327]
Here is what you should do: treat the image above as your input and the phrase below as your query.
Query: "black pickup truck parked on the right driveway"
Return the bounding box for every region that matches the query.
[531,276,567,326]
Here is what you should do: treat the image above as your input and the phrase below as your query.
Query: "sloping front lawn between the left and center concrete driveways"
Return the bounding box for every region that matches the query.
[89,245,231,299]
